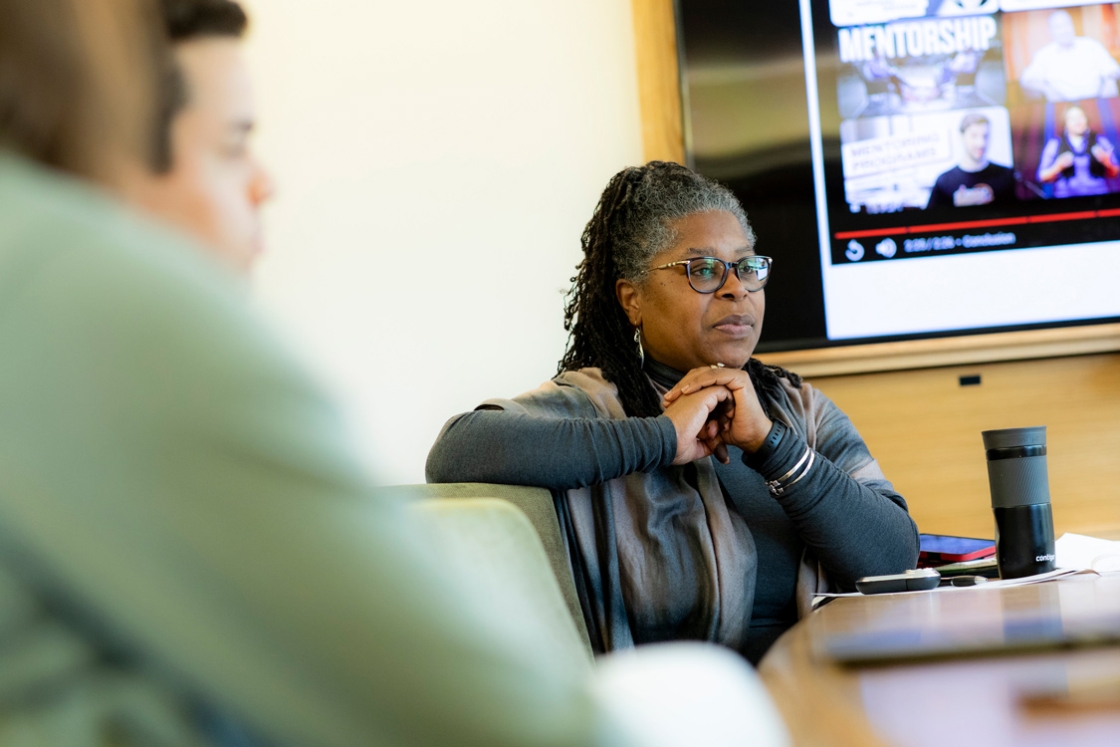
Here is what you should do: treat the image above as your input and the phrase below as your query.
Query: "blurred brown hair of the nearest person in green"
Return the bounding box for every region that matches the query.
[0,0,162,180]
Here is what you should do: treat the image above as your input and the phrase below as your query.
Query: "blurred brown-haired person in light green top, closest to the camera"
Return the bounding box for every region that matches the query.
[0,0,782,747]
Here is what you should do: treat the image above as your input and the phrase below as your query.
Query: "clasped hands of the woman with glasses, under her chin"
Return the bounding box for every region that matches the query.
[662,365,774,465]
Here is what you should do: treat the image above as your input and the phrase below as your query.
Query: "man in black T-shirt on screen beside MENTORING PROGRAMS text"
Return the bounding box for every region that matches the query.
[925,112,1015,209]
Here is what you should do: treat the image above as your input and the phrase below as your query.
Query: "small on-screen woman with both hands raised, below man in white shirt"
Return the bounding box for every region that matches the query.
[1038,106,1120,197]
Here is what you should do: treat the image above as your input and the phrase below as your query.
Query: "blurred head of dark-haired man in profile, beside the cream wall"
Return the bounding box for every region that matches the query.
[140,0,272,272]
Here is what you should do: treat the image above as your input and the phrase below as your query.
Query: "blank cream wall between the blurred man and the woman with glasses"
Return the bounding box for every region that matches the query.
[240,0,642,483]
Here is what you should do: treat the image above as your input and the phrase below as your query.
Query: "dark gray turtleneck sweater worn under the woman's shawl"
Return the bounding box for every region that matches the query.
[427,360,918,663]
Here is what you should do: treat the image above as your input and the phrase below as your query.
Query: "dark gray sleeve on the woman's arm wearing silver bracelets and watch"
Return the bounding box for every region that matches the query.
[744,390,918,588]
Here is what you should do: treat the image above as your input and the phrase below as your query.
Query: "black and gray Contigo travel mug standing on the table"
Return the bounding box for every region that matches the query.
[980,426,1054,578]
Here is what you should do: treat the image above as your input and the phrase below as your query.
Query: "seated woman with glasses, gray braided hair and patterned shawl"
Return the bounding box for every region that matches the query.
[428,161,918,662]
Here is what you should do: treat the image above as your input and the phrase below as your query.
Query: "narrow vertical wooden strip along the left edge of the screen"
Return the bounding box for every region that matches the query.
[631,0,684,164]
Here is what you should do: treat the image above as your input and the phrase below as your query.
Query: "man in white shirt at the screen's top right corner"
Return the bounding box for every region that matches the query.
[1019,10,1120,101]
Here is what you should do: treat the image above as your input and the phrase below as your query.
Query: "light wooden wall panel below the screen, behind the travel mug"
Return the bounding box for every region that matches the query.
[812,354,1120,539]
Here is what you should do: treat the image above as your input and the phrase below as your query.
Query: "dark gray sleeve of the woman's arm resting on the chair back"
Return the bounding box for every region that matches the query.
[426,409,676,491]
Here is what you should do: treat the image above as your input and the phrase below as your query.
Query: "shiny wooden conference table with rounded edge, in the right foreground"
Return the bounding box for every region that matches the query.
[759,575,1120,747]
